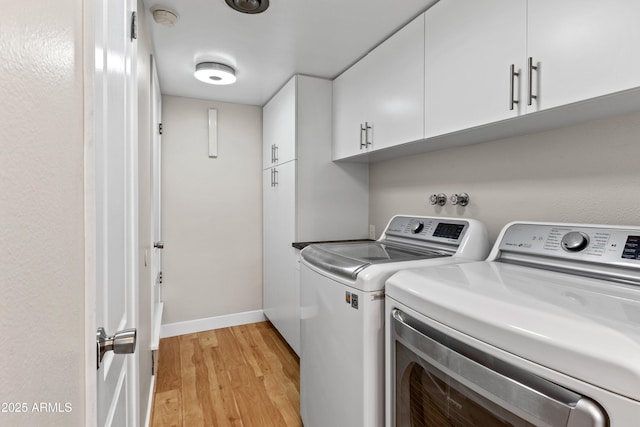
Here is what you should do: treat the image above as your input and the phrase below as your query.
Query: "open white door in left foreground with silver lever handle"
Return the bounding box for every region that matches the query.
[87,0,139,427]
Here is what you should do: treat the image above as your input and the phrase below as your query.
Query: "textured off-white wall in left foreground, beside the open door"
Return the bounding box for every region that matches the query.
[0,0,85,426]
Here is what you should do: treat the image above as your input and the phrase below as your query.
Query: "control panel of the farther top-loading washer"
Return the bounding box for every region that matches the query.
[385,216,469,244]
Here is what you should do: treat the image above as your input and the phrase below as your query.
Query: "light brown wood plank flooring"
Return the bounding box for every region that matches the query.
[151,322,302,427]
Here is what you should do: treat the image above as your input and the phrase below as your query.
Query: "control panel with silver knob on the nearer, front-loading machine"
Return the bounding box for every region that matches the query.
[499,223,640,267]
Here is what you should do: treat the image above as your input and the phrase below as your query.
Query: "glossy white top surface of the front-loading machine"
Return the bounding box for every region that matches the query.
[386,262,640,400]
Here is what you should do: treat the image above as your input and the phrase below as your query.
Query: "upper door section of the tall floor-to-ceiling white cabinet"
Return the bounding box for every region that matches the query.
[262,76,296,168]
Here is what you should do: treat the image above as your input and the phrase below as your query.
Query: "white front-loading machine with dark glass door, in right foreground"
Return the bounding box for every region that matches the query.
[385,222,640,427]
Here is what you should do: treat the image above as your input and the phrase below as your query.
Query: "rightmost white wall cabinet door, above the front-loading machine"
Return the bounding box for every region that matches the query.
[528,0,640,110]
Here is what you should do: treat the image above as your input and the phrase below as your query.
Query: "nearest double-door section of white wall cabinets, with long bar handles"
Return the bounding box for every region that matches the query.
[425,0,640,138]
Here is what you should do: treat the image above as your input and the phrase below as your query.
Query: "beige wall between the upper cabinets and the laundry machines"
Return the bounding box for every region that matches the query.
[369,113,640,244]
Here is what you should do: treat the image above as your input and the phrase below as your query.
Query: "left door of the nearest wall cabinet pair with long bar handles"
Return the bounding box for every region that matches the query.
[425,0,527,138]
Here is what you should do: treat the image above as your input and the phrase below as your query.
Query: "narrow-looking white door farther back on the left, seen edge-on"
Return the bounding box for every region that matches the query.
[151,58,164,350]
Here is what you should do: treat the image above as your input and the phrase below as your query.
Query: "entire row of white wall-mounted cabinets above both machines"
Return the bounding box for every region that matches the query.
[333,0,640,162]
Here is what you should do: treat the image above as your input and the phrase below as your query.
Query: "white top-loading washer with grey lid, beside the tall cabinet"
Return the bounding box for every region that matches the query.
[300,215,490,427]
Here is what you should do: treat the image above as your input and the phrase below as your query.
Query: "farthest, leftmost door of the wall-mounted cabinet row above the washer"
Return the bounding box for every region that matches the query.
[332,62,369,160]
